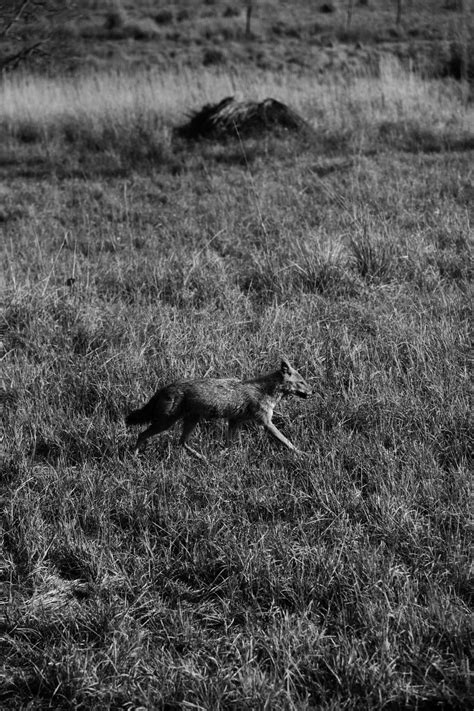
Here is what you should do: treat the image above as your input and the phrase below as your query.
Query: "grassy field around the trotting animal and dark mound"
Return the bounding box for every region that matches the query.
[0,54,474,711]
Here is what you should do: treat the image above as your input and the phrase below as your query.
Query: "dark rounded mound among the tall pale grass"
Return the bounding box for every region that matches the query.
[175,96,312,140]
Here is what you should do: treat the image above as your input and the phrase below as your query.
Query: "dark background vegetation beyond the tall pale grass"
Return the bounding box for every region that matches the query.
[0,0,474,79]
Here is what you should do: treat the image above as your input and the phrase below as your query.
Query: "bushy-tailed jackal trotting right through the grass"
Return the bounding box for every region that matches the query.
[125,359,311,459]
